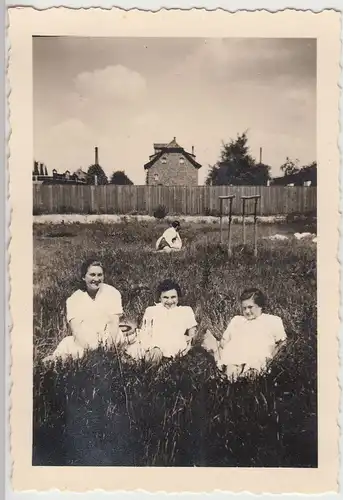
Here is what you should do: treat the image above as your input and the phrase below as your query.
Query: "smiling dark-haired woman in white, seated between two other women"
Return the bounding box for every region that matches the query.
[126,279,197,362]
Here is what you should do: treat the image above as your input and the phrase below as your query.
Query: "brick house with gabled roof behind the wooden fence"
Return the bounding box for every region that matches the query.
[144,137,201,186]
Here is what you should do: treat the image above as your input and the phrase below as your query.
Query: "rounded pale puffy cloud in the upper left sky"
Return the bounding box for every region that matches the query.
[74,65,146,104]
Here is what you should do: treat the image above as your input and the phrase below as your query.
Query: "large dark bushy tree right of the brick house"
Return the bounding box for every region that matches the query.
[206,132,270,186]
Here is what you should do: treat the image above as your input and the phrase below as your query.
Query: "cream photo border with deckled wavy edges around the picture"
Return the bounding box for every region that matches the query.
[8,8,340,493]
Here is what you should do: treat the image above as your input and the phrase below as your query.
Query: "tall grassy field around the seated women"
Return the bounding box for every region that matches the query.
[33,222,317,467]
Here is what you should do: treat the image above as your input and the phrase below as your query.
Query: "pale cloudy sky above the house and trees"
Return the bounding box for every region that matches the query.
[33,37,316,184]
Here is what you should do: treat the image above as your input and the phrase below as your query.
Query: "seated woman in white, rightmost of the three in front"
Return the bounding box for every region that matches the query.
[202,288,286,379]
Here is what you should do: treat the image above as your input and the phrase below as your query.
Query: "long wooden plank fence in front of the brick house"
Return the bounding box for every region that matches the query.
[33,184,317,215]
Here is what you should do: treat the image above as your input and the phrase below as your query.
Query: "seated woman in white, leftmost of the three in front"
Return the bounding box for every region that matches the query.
[44,259,125,361]
